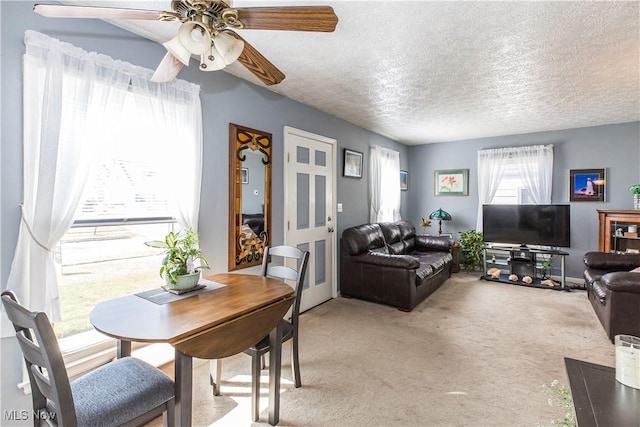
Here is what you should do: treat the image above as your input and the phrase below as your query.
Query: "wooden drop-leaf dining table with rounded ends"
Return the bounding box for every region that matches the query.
[90,273,294,426]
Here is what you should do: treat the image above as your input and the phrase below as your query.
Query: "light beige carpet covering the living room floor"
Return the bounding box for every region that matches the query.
[148,273,615,426]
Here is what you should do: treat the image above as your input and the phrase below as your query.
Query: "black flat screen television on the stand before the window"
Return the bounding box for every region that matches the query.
[482,205,571,248]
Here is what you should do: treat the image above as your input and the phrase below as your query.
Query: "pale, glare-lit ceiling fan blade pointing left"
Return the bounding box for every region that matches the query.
[33,4,172,21]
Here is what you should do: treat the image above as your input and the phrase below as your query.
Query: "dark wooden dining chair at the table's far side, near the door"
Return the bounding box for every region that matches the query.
[211,246,309,421]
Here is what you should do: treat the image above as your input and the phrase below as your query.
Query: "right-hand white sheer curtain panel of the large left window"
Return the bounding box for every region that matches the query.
[131,76,202,230]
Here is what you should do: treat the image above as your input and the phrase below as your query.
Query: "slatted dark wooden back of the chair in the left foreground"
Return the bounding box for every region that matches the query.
[2,291,77,426]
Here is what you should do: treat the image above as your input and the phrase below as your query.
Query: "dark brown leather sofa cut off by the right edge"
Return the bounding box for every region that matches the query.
[584,252,640,342]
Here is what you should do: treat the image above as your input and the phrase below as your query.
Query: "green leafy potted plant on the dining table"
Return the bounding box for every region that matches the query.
[145,228,210,289]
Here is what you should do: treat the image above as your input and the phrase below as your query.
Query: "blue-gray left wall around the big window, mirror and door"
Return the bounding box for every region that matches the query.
[0,1,407,425]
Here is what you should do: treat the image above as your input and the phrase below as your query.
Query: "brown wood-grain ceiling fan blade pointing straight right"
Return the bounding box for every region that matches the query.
[234,6,338,33]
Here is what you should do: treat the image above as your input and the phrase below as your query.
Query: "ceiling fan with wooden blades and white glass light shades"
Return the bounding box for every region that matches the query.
[33,0,338,85]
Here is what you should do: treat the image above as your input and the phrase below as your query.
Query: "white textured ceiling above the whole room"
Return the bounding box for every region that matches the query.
[57,0,640,144]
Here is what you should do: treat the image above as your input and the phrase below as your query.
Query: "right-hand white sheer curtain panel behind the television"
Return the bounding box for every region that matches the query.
[514,145,553,205]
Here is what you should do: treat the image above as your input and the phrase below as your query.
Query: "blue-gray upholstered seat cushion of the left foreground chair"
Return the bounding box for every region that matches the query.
[52,357,175,426]
